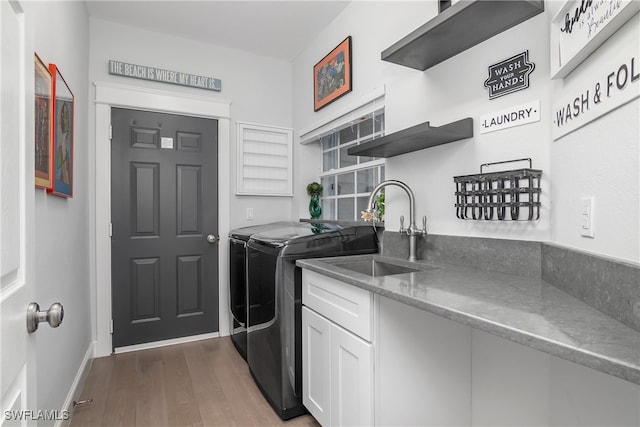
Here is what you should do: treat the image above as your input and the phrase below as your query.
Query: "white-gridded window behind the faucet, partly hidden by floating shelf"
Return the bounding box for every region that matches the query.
[319,109,385,221]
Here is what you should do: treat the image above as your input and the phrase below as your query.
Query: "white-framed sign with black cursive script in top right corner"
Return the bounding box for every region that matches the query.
[550,0,640,79]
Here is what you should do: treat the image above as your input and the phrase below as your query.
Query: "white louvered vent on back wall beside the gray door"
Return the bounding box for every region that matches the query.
[236,122,293,196]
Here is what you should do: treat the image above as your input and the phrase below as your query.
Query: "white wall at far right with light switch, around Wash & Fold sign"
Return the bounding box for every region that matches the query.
[550,9,640,262]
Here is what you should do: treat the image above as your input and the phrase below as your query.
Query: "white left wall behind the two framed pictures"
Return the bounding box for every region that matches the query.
[22,1,91,422]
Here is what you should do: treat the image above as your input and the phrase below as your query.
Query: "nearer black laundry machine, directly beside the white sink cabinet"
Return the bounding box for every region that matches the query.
[246,223,378,420]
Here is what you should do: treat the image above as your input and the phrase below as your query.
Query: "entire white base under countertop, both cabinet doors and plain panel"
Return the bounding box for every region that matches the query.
[302,270,640,426]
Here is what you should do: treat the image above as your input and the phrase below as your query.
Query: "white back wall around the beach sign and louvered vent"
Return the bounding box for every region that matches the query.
[89,18,292,228]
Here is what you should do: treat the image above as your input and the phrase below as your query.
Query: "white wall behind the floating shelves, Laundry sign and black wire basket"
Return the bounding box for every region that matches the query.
[386,10,553,240]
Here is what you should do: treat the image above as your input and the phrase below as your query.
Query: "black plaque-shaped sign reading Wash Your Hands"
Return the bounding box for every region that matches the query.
[484,50,536,99]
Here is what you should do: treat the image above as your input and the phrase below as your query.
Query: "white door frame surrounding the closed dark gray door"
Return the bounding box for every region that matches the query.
[89,82,231,357]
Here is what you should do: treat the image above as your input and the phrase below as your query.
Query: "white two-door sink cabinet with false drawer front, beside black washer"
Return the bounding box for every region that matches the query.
[302,270,373,426]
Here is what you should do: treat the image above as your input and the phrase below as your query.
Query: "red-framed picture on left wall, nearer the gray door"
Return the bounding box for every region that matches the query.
[48,64,74,197]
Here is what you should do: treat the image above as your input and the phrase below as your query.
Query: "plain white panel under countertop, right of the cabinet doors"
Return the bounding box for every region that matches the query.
[374,297,640,427]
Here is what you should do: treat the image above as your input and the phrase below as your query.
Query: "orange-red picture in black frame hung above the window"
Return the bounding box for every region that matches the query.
[313,36,351,111]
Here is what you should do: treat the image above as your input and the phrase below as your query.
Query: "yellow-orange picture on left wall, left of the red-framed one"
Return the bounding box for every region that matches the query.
[34,54,53,189]
